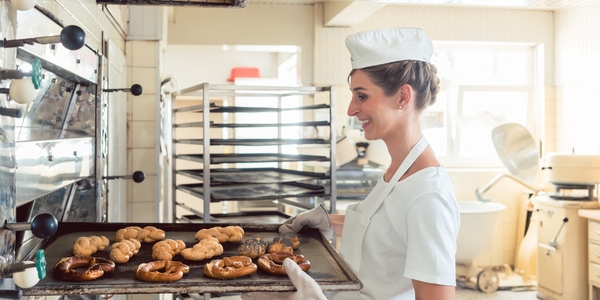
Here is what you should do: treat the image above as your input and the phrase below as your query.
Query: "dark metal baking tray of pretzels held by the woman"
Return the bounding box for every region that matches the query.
[23,222,362,296]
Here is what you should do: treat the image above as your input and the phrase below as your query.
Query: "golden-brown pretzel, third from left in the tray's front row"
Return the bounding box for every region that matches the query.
[204,256,257,279]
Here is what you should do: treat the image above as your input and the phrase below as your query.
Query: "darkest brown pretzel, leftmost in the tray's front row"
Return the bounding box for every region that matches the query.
[54,256,115,281]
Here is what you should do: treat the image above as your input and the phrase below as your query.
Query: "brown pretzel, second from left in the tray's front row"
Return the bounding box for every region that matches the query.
[134,260,190,282]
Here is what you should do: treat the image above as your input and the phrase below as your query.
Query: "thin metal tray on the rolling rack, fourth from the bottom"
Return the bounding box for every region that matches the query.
[176,153,330,164]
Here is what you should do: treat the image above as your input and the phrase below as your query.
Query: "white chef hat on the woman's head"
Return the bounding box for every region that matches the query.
[346,28,433,69]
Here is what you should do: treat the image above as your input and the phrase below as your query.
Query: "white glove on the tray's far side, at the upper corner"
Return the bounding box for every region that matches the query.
[279,204,335,240]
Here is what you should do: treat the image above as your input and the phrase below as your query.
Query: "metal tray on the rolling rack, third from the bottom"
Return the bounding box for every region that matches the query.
[177,168,329,184]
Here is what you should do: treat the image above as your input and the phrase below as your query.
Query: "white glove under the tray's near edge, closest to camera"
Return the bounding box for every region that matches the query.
[241,258,327,300]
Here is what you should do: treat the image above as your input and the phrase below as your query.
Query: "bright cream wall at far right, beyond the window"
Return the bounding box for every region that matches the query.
[546,7,600,154]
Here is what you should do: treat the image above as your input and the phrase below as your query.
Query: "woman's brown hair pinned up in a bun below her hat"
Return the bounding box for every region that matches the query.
[348,60,440,111]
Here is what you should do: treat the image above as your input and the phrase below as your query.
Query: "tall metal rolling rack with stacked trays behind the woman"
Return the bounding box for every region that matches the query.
[170,83,336,223]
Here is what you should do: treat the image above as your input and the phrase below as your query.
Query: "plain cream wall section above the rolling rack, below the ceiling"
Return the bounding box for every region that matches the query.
[168,3,314,85]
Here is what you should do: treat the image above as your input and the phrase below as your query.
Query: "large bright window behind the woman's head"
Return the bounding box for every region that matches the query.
[421,43,542,167]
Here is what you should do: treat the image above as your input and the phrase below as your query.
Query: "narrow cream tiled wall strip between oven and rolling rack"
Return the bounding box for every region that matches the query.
[126,41,160,222]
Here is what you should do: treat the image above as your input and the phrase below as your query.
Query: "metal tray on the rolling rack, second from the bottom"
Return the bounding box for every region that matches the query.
[177,182,325,202]
